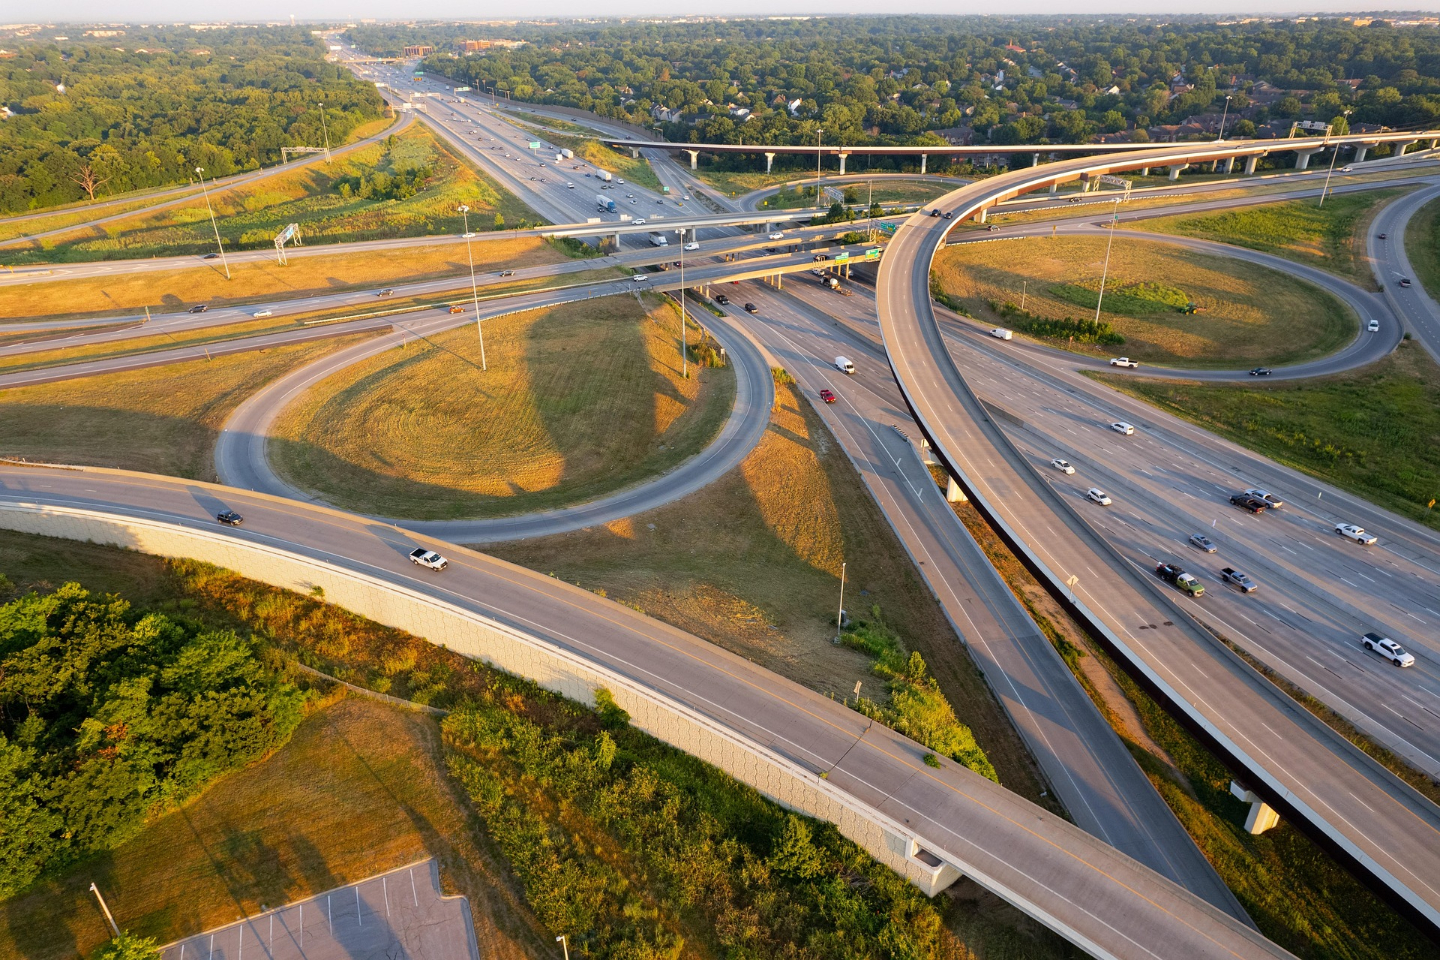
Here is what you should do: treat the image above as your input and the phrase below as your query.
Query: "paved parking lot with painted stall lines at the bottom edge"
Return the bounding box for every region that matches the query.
[160,859,480,960]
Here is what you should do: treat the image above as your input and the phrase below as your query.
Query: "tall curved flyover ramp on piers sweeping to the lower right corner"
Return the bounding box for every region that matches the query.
[877,145,1440,927]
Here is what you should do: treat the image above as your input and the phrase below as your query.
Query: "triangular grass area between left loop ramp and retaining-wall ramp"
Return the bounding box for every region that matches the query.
[487,386,1044,805]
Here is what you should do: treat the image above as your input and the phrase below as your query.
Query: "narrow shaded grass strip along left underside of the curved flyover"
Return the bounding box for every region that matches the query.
[938,477,1433,960]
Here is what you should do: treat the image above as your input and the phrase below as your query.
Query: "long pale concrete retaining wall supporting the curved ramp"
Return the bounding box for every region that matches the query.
[0,504,960,895]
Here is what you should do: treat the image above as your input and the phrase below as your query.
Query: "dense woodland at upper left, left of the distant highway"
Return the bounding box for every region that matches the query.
[0,27,383,212]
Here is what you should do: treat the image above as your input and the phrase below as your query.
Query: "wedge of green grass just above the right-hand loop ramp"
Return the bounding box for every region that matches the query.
[1135,190,1400,289]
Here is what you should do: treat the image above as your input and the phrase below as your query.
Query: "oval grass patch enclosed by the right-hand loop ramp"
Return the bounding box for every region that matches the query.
[933,237,1358,368]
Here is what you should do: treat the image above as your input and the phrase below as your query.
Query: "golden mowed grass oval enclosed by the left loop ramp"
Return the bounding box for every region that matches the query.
[271,295,734,518]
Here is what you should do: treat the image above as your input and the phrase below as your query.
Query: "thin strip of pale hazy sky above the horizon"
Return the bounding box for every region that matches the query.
[28,0,1440,23]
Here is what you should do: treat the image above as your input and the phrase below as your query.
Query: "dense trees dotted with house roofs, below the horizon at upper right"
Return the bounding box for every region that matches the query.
[348,17,1440,151]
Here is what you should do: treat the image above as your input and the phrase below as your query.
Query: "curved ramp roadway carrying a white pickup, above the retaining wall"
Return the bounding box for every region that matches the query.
[0,466,1289,960]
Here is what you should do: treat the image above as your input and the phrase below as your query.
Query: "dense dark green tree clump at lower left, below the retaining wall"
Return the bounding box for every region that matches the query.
[0,577,304,897]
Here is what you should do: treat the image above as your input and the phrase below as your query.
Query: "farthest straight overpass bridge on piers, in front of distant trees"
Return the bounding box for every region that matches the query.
[605,131,1440,177]
